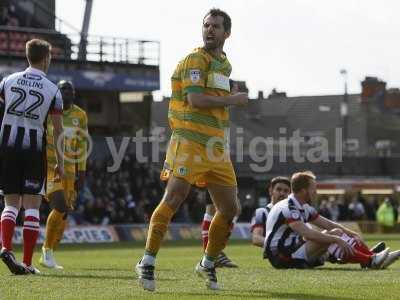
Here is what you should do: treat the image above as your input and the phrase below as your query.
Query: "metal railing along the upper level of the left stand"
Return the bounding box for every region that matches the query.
[0,26,160,66]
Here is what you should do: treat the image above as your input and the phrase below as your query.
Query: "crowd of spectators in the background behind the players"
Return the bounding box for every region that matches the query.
[0,155,400,225]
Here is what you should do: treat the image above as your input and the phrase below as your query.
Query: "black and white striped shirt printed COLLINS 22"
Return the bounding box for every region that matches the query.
[0,67,63,151]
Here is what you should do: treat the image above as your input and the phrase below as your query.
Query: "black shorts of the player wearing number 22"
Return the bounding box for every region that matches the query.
[0,149,47,195]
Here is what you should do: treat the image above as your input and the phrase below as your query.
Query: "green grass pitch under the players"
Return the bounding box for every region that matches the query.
[0,235,400,300]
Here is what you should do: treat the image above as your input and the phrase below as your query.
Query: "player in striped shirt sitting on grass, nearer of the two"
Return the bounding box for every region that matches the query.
[264,172,400,269]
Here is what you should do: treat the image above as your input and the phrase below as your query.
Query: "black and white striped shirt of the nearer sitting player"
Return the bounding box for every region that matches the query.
[264,194,318,256]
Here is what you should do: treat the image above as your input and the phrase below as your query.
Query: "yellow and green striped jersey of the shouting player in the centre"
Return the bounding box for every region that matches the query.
[168,48,232,148]
